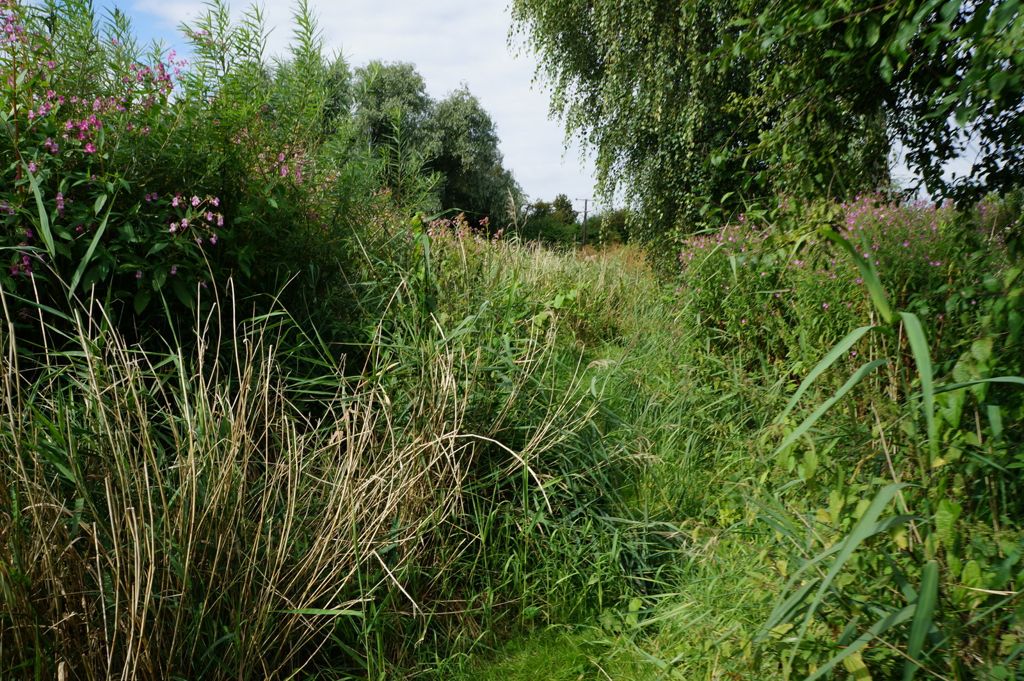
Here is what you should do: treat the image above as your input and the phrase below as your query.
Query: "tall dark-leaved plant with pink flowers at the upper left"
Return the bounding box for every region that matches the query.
[0,0,226,313]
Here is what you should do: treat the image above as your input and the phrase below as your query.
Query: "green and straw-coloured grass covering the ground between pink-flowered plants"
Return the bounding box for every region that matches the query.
[0,199,1024,681]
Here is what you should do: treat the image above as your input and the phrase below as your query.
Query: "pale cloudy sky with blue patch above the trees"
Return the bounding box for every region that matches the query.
[96,0,594,211]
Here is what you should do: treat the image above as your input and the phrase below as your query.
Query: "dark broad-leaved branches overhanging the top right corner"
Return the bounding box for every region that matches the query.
[737,0,1024,200]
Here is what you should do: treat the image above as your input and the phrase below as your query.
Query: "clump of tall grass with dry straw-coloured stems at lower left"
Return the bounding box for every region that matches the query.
[0,266,602,679]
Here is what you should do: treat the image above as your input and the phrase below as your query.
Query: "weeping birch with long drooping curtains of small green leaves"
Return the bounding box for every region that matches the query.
[513,0,888,249]
